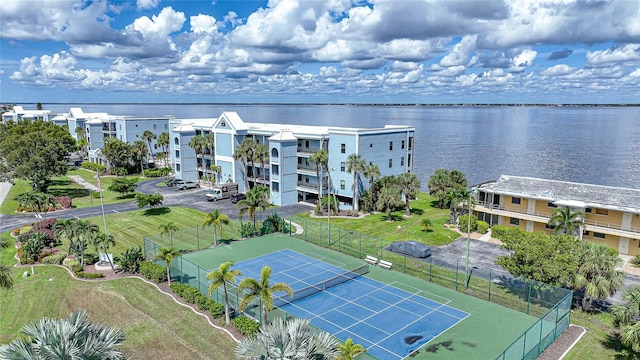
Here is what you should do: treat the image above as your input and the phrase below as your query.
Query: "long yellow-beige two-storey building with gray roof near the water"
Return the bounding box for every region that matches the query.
[474,175,640,256]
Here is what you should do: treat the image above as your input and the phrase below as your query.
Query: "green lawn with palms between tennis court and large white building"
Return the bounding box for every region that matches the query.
[304,192,459,246]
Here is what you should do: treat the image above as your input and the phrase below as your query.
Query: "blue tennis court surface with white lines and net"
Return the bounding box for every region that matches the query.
[234,250,469,359]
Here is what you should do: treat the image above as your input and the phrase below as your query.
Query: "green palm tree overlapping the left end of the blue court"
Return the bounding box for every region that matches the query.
[238,266,293,325]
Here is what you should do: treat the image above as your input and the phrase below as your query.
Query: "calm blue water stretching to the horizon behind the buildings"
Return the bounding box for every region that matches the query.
[45,104,640,188]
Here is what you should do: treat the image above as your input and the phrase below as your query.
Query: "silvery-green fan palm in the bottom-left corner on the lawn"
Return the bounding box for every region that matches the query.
[0,310,126,360]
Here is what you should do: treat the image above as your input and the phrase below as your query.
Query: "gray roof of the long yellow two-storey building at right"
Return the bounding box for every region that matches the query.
[477,175,640,213]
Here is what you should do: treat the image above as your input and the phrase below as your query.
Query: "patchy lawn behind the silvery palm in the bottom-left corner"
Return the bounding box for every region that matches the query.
[0,262,235,359]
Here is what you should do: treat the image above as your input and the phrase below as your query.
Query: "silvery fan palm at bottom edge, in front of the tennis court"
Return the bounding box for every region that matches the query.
[235,317,340,360]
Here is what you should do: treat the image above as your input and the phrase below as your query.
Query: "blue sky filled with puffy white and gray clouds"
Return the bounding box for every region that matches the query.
[0,0,640,104]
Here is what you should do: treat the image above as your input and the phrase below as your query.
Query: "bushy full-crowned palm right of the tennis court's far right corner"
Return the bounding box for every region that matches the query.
[574,242,624,310]
